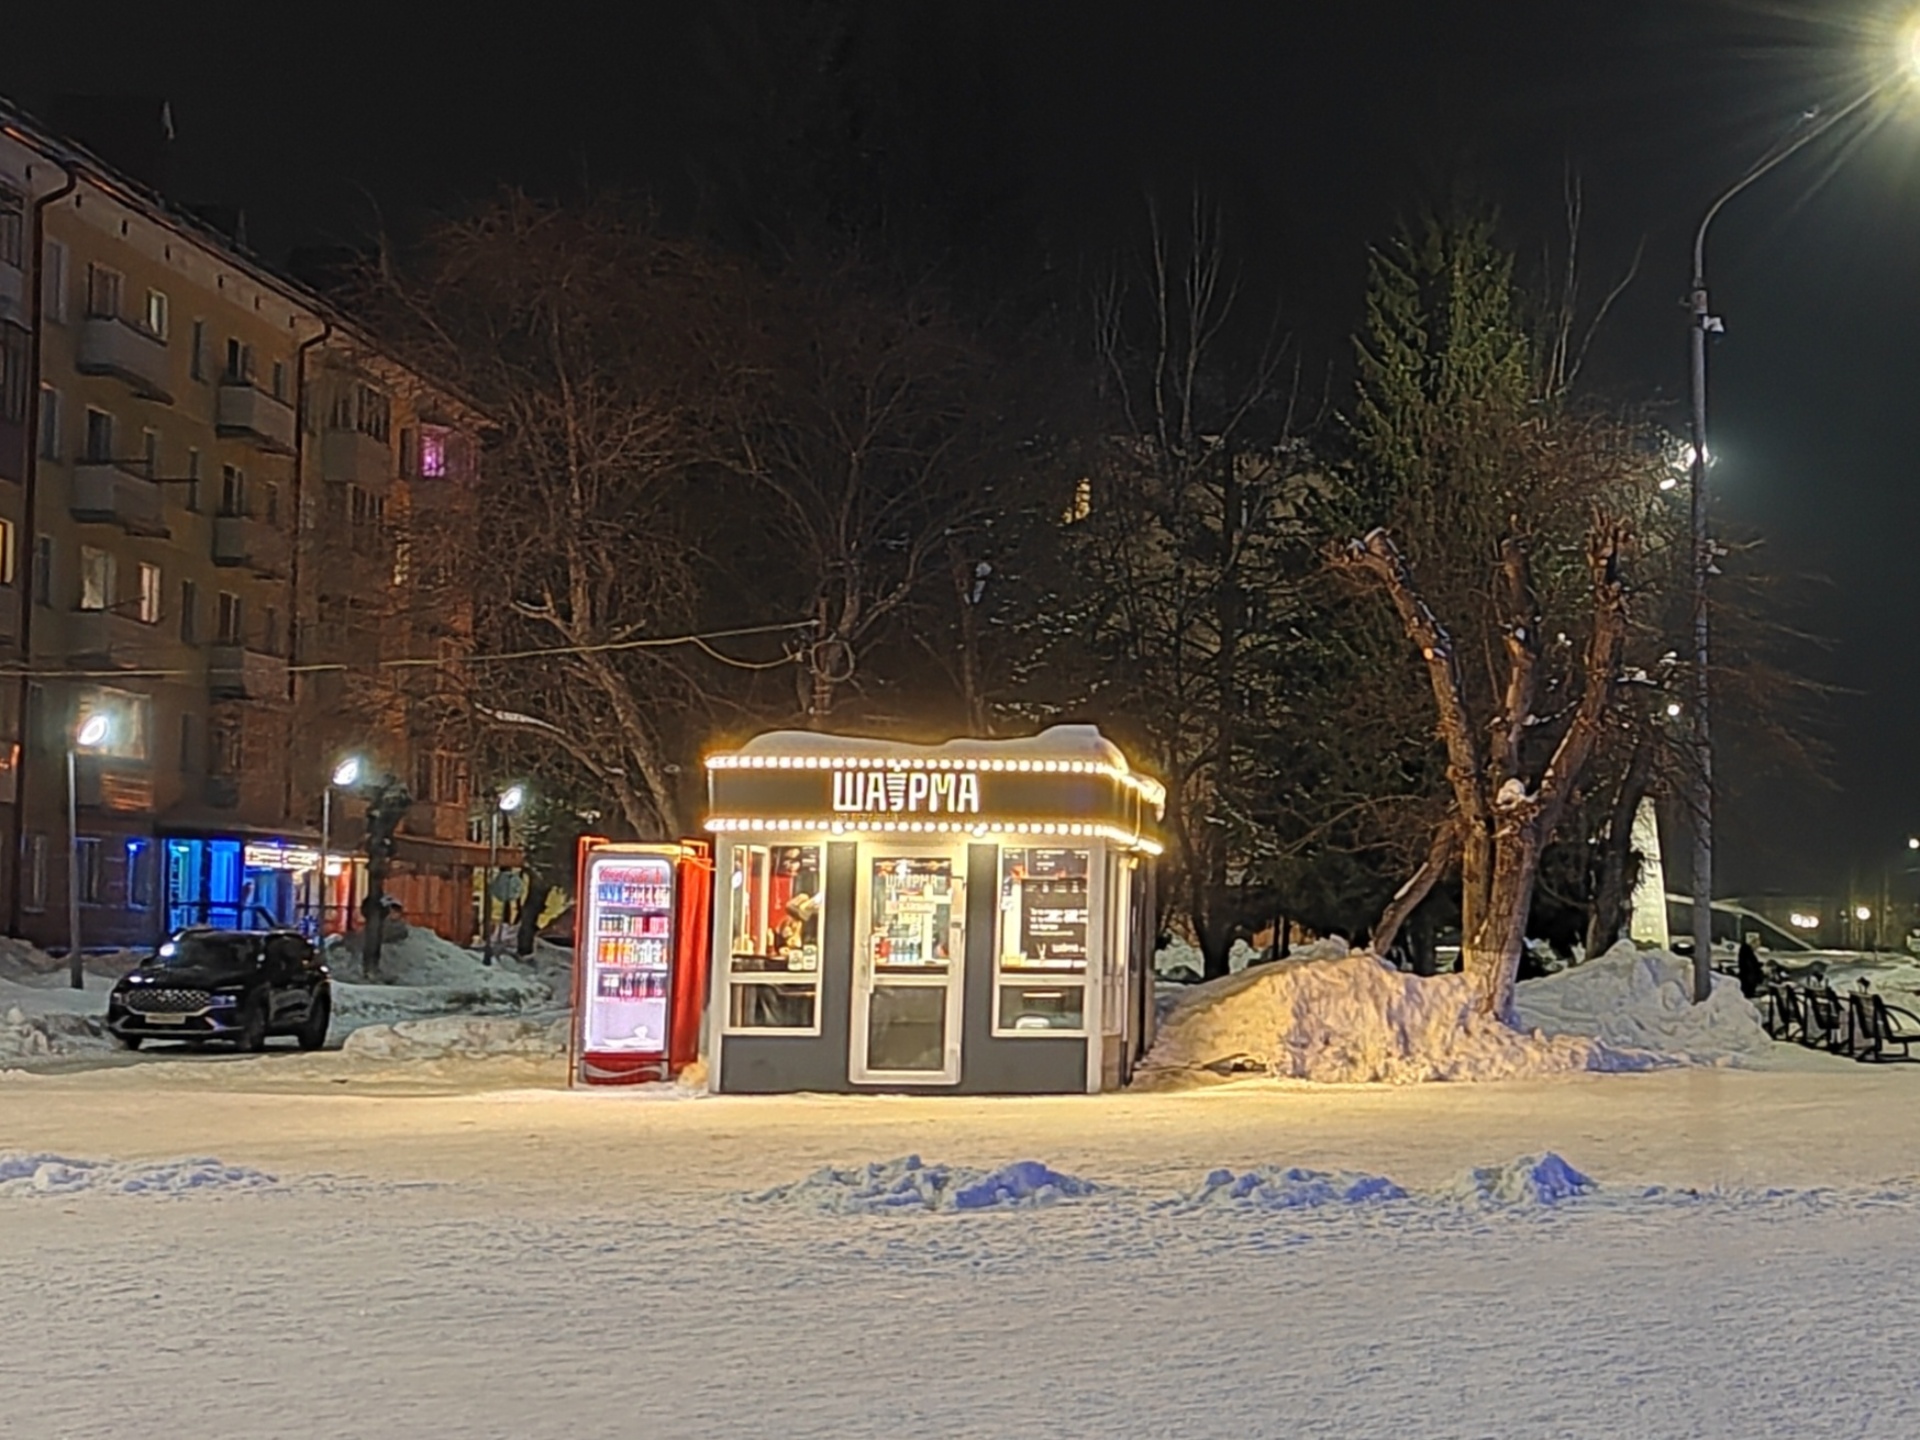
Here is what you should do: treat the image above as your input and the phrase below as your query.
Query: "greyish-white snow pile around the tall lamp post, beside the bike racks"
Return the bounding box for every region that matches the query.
[1513,941,1774,1066]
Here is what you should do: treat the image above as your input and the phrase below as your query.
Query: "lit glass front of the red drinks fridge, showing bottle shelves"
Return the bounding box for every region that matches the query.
[584,854,674,1056]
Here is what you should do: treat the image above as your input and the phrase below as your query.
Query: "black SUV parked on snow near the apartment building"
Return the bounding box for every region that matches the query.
[108,925,334,1050]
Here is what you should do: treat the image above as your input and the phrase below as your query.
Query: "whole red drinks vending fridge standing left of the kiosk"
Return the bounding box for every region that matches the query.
[568,837,712,1085]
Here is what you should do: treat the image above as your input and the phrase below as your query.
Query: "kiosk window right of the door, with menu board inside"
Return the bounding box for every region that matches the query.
[993,847,1092,1035]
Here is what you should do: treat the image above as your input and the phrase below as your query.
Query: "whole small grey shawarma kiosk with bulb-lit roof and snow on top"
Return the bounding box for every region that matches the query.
[705,726,1165,1094]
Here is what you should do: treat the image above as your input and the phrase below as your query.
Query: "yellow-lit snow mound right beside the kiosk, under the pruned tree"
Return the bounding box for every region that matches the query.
[1144,952,1663,1085]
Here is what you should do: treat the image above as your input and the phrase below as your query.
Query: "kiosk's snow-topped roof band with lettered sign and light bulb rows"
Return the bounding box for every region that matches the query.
[707,726,1165,854]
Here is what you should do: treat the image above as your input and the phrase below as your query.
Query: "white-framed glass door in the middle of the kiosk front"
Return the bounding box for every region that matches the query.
[849,843,966,1085]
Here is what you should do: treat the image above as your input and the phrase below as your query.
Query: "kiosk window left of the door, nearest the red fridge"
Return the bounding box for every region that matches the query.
[728,845,826,1033]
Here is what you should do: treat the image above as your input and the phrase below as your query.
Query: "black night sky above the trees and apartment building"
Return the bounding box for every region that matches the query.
[11,0,1920,893]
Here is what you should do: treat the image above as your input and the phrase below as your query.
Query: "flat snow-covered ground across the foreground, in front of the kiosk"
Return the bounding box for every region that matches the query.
[0,1056,1920,1438]
